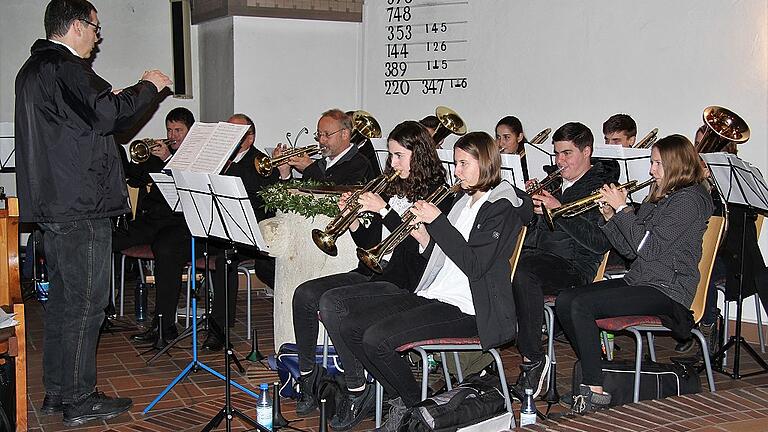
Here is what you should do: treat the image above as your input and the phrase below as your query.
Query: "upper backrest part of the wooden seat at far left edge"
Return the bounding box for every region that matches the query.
[0,197,23,305]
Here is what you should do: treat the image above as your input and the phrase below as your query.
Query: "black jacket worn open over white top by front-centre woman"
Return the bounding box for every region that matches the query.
[420,181,533,350]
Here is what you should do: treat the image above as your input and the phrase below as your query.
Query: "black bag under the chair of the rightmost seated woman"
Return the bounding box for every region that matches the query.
[573,360,701,406]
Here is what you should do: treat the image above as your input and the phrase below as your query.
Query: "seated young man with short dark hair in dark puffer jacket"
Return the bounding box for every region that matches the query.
[512,123,619,397]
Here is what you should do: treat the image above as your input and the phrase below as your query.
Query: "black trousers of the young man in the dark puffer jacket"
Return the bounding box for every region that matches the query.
[512,249,589,362]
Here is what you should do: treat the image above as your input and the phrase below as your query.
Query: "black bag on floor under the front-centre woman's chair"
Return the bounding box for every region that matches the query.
[400,373,506,432]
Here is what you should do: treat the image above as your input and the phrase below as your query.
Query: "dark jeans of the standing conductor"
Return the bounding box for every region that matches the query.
[40,219,112,404]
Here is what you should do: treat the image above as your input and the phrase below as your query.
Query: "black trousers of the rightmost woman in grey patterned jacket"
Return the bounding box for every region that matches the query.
[556,279,681,386]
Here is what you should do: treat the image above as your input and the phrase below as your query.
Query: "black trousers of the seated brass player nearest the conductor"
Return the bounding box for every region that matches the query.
[112,216,191,329]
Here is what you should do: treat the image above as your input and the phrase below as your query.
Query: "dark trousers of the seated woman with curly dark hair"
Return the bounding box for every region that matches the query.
[293,271,368,378]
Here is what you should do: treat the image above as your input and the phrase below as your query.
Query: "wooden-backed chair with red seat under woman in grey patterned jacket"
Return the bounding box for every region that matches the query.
[597,216,724,402]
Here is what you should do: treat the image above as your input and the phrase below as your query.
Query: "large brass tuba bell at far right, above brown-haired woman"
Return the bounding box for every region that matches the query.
[696,105,750,153]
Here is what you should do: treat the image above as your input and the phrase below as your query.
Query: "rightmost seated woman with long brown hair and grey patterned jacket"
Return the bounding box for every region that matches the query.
[557,135,714,414]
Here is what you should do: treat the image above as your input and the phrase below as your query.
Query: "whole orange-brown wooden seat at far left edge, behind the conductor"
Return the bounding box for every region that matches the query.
[0,197,27,431]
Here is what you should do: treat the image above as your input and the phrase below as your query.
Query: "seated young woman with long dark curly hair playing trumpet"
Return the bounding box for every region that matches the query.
[293,121,445,427]
